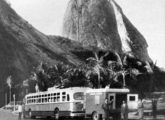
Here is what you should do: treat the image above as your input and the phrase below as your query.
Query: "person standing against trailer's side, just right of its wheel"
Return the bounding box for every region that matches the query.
[102,98,109,120]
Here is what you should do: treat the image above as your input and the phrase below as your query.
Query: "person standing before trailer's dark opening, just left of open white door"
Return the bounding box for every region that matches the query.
[121,101,128,120]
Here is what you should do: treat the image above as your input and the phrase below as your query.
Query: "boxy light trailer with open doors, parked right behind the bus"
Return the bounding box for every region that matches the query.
[85,88,138,120]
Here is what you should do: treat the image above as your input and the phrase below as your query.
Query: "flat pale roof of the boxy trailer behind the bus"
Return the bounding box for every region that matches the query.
[86,88,130,93]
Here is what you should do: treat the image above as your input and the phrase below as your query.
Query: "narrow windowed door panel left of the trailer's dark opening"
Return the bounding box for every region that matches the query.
[108,93,116,109]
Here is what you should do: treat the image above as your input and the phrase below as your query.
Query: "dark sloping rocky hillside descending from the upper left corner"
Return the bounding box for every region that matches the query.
[0,0,93,106]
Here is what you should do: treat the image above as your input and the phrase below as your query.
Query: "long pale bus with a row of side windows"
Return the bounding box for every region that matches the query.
[24,87,90,119]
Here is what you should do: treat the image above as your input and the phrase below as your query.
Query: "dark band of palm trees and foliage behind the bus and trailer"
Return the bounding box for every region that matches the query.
[18,52,161,98]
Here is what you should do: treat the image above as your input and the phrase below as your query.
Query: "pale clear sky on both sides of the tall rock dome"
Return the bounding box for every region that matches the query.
[7,0,165,68]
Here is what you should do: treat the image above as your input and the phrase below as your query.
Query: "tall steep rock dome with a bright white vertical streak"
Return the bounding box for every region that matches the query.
[63,0,152,62]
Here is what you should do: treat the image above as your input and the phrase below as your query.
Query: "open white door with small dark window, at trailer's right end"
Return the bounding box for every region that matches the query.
[127,94,138,110]
